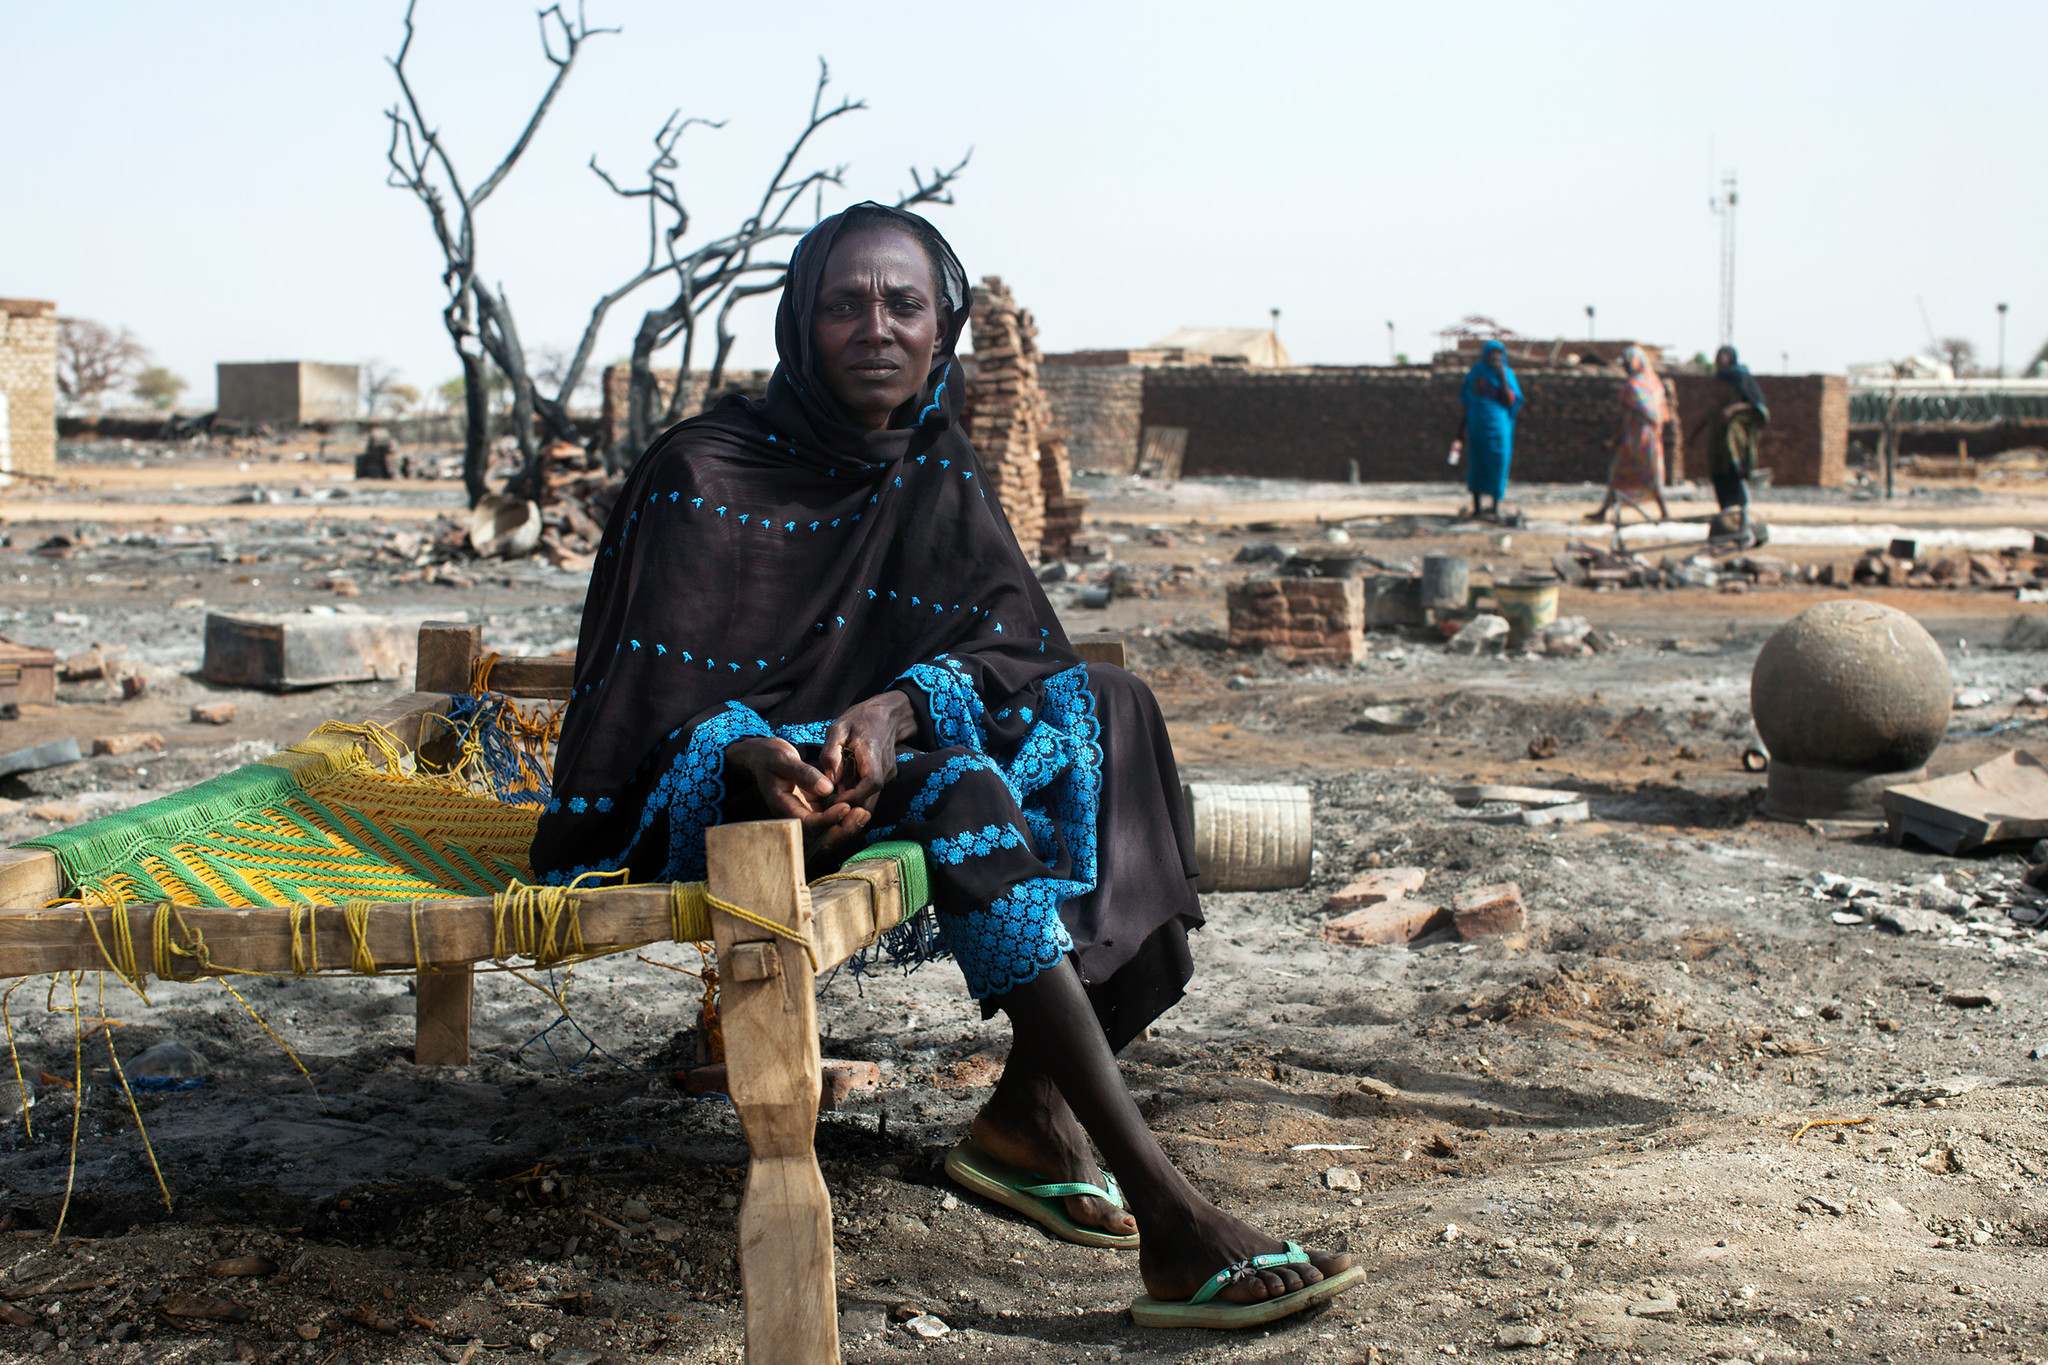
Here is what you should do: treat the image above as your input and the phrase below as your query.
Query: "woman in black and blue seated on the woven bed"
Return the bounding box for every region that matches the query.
[532,205,1360,1326]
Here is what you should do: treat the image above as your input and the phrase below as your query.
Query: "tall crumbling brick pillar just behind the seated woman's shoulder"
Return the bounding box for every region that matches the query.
[967,274,1087,559]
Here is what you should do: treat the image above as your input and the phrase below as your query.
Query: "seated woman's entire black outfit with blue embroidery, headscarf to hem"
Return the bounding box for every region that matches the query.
[532,209,1200,1044]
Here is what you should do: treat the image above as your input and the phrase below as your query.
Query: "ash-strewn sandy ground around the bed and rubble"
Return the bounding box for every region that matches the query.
[0,446,2048,1365]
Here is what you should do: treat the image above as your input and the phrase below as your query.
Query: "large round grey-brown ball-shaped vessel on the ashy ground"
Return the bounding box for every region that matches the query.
[1749,600,1954,774]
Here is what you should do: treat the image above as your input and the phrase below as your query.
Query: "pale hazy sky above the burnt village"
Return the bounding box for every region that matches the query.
[0,0,2048,401]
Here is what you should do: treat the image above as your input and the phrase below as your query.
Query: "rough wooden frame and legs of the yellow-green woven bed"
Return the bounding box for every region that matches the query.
[0,622,1124,1365]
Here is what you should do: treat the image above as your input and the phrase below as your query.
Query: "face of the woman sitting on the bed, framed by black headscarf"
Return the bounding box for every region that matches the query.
[811,227,942,432]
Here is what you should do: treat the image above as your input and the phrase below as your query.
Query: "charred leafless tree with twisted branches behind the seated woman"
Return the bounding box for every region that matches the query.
[385,0,967,503]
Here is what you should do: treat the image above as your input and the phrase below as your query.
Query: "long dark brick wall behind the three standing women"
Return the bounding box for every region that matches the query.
[1141,366,1849,483]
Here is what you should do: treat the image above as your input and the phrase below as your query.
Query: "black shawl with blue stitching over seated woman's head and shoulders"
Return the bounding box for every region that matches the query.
[532,205,1077,880]
